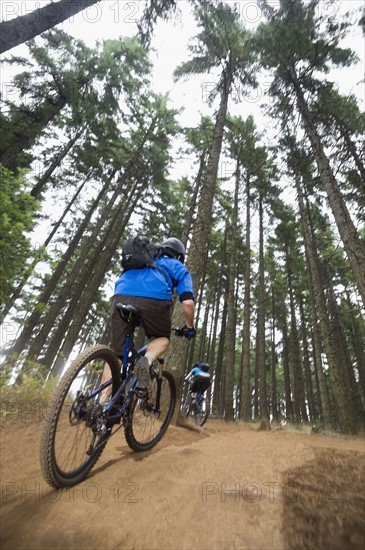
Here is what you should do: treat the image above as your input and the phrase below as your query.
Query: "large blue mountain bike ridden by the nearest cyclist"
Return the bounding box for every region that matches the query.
[40,304,179,489]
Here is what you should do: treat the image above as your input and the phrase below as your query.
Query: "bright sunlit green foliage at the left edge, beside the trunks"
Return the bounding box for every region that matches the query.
[0,165,38,303]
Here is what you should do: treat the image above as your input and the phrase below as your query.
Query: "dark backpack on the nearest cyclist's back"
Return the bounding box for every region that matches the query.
[122,235,160,271]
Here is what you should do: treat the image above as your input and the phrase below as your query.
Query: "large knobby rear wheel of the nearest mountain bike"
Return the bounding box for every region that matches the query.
[40,345,120,489]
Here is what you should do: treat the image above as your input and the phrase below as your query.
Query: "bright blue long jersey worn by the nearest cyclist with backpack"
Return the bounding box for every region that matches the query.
[114,256,194,300]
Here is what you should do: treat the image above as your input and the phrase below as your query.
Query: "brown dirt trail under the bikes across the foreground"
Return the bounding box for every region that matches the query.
[1,420,365,550]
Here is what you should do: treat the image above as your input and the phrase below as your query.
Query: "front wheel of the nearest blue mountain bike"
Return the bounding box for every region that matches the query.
[124,371,176,452]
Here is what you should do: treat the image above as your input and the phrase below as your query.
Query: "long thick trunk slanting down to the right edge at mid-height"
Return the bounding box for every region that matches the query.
[289,68,365,306]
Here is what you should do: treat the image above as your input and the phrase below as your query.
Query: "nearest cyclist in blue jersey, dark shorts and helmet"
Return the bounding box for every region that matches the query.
[111,237,196,396]
